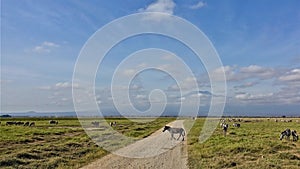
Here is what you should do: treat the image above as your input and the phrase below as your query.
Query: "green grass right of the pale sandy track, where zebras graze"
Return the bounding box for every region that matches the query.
[187,119,300,169]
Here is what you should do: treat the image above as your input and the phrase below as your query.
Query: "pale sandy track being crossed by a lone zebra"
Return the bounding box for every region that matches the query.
[82,120,188,169]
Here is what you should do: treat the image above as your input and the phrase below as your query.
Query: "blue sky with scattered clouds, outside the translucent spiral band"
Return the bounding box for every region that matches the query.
[1,0,300,113]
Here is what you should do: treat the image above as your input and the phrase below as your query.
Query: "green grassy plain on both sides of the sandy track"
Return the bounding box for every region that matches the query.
[0,118,300,169]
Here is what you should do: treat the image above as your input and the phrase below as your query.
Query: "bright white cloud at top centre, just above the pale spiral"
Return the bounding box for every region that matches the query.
[138,0,176,21]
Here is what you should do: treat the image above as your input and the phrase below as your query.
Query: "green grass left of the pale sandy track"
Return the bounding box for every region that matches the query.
[0,118,175,169]
